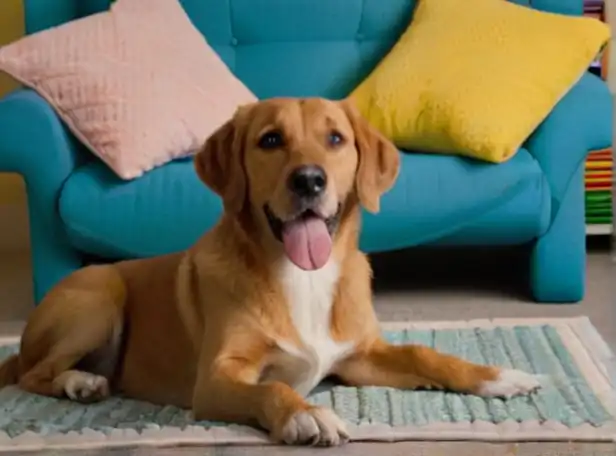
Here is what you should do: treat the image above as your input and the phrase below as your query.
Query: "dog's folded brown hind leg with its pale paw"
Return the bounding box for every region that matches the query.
[19,266,126,402]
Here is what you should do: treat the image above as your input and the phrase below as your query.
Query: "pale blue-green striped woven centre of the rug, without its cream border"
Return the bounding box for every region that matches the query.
[0,325,613,438]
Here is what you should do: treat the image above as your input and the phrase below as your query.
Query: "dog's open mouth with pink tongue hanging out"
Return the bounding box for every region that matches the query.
[263,204,342,271]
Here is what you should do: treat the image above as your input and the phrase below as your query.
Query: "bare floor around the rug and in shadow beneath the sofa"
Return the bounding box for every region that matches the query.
[0,241,616,456]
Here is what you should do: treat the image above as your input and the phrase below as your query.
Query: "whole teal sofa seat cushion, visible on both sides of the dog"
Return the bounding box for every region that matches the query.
[59,149,550,259]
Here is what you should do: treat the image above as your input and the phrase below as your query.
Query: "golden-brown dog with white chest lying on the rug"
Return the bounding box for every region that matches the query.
[0,98,540,446]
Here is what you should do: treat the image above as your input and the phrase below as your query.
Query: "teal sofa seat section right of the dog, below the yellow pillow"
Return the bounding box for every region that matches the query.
[361,149,551,252]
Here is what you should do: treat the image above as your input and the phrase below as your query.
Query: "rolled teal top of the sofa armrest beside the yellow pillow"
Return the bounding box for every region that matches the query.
[524,73,613,209]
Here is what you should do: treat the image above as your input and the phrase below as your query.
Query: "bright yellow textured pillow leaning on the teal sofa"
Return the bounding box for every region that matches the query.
[351,0,610,163]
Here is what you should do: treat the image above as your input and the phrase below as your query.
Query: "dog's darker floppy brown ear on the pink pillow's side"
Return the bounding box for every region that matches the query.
[194,115,246,214]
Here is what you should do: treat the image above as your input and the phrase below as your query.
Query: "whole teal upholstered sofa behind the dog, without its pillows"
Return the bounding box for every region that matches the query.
[0,0,612,302]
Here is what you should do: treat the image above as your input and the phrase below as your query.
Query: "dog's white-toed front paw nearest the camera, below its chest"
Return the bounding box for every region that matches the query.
[277,407,349,446]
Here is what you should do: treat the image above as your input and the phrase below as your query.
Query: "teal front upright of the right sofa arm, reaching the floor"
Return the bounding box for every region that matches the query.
[530,162,586,304]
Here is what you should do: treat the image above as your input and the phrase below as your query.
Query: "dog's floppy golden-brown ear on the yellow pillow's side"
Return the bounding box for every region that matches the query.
[341,99,400,213]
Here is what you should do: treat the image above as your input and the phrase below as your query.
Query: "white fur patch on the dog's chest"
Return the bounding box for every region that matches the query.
[268,259,353,395]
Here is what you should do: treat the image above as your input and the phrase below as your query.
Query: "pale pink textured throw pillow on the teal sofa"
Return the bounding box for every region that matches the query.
[0,0,256,179]
